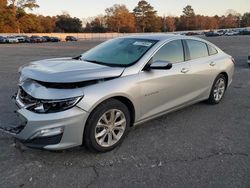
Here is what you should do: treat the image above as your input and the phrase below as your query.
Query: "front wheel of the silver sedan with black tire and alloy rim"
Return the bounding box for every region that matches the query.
[83,99,130,152]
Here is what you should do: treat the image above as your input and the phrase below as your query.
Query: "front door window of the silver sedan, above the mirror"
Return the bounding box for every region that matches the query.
[153,40,184,63]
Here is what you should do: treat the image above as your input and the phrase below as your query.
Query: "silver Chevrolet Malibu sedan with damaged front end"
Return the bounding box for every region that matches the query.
[8,34,234,152]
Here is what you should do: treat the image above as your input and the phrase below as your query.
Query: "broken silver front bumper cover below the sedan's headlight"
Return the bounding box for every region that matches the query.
[14,106,88,150]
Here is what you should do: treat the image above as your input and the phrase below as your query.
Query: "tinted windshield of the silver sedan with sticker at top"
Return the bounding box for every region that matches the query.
[81,38,158,67]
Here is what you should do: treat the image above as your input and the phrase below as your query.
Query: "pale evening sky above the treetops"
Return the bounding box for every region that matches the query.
[33,0,250,19]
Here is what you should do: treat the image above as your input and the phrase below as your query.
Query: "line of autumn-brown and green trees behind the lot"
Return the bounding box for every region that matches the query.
[0,0,250,33]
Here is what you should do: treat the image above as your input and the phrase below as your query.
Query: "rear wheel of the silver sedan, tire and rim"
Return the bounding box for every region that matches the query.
[207,74,227,104]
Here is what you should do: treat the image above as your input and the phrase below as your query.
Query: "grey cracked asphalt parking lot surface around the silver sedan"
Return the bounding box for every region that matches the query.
[0,36,250,188]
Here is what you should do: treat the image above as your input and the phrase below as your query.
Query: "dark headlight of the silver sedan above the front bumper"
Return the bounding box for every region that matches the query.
[27,97,82,113]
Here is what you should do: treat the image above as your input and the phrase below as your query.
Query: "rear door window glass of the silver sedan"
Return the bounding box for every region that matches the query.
[186,40,208,59]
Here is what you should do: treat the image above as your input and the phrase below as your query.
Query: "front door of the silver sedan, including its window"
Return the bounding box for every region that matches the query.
[139,40,192,120]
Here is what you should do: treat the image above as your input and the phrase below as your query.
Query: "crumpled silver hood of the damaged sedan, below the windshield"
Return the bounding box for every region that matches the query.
[19,58,125,83]
